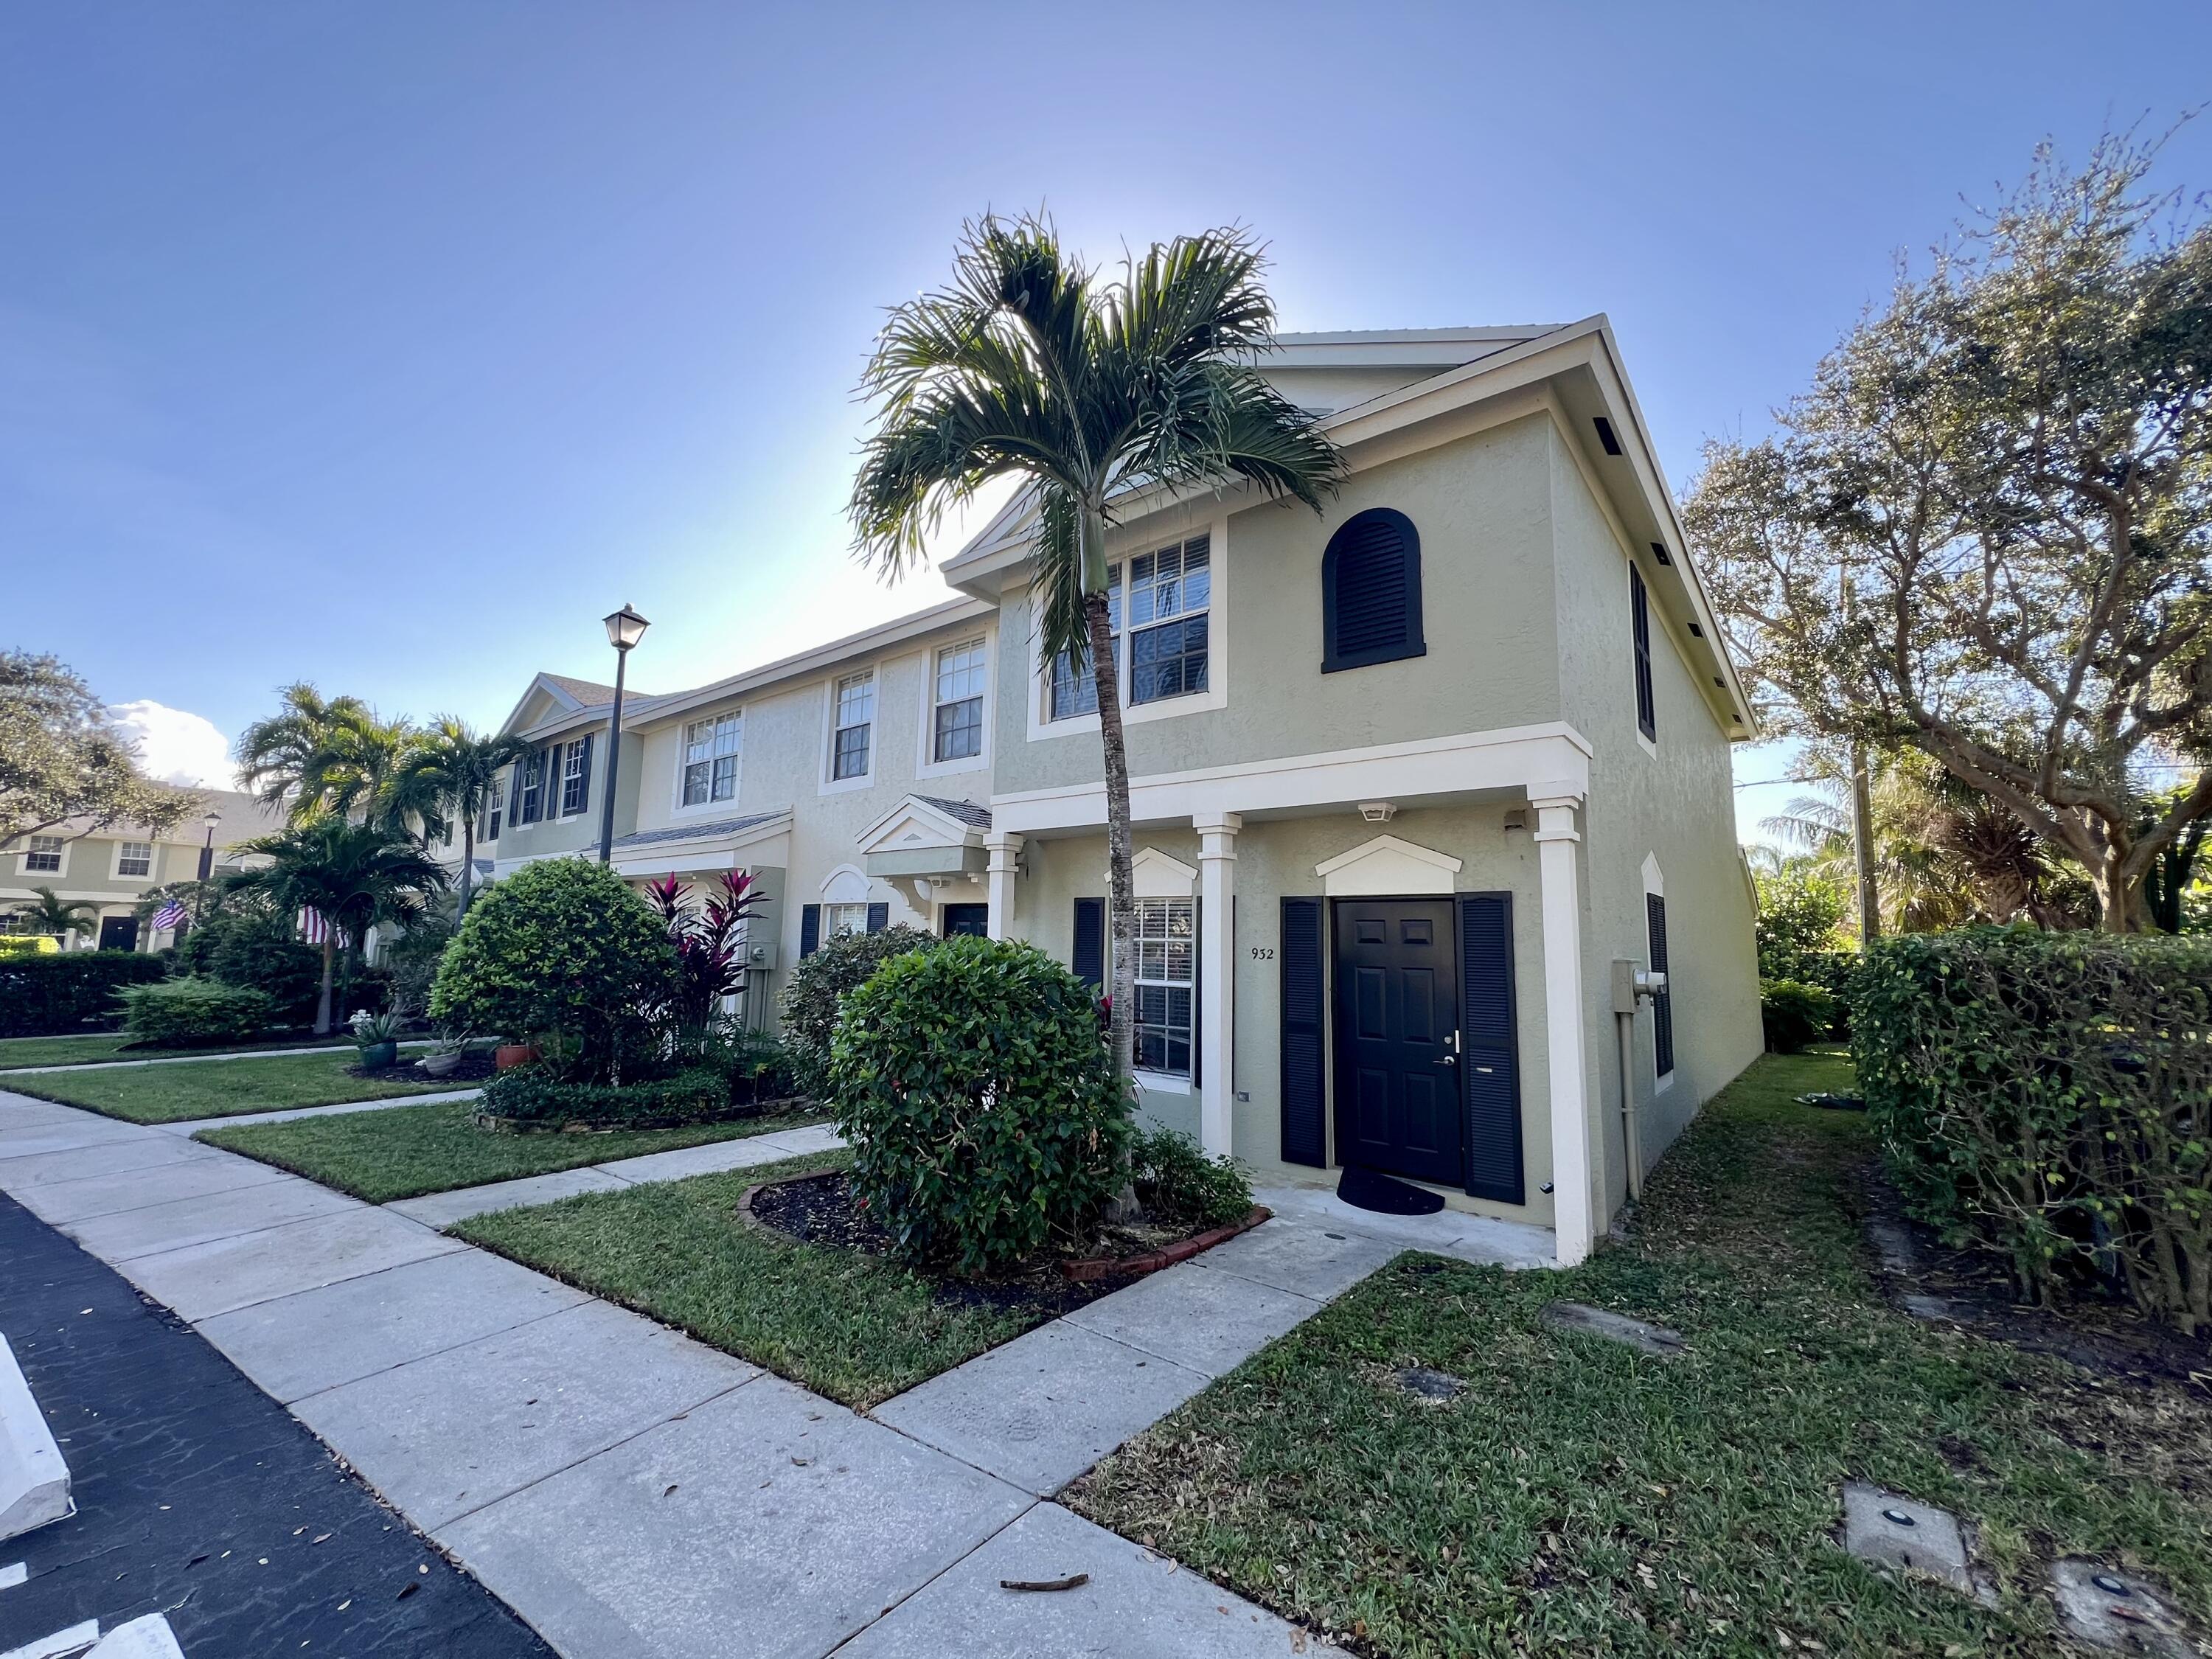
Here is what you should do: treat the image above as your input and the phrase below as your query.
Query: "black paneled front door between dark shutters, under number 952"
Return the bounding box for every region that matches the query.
[1334,898,1467,1186]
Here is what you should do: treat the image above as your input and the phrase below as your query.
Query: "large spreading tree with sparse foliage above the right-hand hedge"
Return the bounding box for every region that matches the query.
[1686,137,2212,931]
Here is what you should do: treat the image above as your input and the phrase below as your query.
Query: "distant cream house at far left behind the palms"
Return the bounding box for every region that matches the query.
[0,790,283,951]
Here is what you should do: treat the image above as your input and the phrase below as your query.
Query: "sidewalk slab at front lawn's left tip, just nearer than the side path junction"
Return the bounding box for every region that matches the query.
[199,1250,588,1405]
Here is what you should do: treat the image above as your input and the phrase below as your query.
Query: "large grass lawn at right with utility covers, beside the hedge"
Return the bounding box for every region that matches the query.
[1066,1057,2212,1659]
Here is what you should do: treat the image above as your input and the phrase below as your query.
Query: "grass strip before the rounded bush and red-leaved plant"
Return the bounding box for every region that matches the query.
[195,1099,818,1203]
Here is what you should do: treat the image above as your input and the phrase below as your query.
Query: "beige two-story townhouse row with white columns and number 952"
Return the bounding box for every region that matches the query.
[471,316,1761,1261]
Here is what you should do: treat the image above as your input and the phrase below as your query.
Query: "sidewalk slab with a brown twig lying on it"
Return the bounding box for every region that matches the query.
[838,1504,1338,1659]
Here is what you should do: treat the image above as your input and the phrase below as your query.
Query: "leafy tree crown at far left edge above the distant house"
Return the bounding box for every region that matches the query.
[0,650,199,845]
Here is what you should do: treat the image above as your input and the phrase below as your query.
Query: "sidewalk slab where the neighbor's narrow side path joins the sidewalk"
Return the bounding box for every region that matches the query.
[115,1194,467,1323]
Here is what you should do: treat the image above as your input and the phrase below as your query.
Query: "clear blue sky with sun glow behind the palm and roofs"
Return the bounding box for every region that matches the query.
[0,0,2212,845]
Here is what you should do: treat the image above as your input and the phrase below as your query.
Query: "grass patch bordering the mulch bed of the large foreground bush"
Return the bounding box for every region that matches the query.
[451,1152,1037,1409]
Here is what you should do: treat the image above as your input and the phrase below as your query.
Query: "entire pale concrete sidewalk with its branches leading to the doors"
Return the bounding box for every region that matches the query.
[0,1093,1548,1659]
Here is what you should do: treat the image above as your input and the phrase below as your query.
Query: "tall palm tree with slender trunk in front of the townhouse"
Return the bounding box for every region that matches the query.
[849,217,1343,1077]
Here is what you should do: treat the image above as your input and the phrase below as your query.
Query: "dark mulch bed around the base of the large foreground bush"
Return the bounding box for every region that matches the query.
[741,1170,1267,1316]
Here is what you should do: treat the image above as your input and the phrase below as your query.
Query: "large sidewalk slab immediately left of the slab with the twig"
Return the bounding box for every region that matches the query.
[438,1376,1031,1659]
